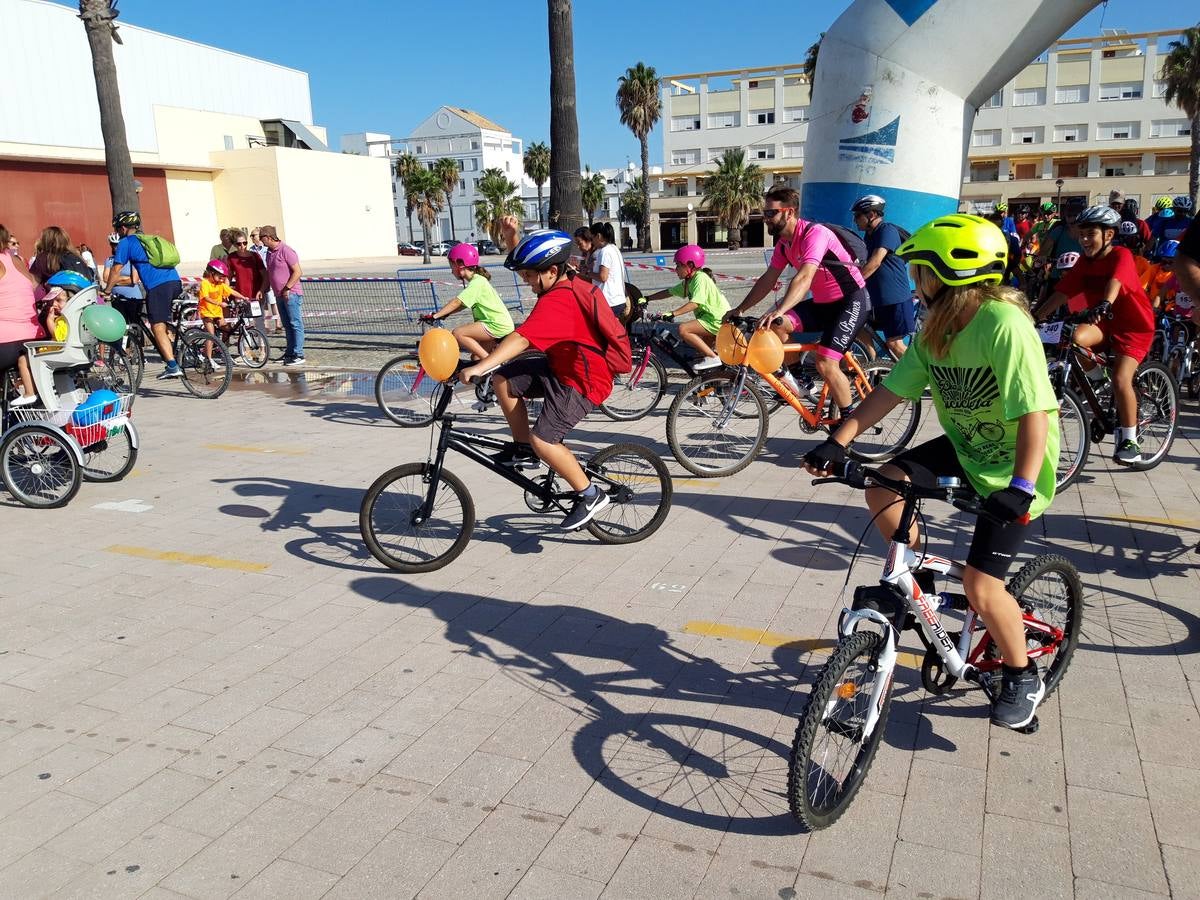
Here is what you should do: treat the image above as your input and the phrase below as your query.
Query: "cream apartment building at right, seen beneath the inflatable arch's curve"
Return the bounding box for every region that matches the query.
[962,30,1190,215]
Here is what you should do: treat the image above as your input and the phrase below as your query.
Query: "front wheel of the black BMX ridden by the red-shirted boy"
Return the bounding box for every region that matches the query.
[359,462,475,572]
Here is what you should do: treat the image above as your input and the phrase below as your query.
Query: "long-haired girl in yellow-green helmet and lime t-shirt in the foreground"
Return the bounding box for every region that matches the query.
[804,215,1058,728]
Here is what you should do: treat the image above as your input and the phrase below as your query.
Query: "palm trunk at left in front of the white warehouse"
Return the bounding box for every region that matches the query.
[79,0,142,212]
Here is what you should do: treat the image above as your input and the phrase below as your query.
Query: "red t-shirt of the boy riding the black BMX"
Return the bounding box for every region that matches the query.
[517,281,612,403]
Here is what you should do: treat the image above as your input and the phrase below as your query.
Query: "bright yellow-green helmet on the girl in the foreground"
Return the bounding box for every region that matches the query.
[896,212,1008,287]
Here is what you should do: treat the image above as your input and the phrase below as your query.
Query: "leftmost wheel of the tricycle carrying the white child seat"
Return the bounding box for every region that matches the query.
[0,425,82,509]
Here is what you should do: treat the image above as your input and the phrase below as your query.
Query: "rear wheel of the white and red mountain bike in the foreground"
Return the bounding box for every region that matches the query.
[984,553,1084,700]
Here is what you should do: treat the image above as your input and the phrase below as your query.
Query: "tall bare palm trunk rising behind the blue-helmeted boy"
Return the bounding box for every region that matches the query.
[547,0,583,234]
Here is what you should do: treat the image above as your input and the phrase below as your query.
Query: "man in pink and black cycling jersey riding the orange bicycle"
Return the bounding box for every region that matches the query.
[726,187,871,415]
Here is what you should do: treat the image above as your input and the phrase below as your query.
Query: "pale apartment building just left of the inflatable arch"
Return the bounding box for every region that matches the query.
[650,64,809,250]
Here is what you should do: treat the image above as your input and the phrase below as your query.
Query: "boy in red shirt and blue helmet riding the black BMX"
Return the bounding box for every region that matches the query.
[458,216,612,532]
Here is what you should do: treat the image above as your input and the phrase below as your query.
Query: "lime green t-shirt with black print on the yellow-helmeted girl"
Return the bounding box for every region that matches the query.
[883,301,1058,516]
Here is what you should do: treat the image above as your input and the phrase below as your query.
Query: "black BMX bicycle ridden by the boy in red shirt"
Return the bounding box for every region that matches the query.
[359,367,672,572]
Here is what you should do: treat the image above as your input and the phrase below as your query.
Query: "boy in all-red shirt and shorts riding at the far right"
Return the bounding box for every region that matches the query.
[1038,206,1154,466]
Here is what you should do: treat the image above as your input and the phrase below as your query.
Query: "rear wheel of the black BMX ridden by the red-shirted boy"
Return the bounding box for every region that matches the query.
[584,444,672,544]
